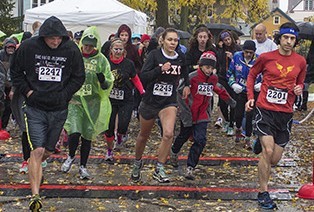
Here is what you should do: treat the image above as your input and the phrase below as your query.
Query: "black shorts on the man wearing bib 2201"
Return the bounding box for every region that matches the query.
[254,107,293,147]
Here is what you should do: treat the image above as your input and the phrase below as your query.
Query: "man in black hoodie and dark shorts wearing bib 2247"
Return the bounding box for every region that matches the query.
[11,16,85,211]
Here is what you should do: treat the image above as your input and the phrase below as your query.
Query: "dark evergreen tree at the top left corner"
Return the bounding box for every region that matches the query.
[0,0,22,35]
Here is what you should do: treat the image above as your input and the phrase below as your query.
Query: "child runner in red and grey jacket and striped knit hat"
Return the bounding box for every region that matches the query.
[170,51,236,180]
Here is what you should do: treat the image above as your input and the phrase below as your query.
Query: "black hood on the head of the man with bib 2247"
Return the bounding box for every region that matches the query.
[39,16,69,39]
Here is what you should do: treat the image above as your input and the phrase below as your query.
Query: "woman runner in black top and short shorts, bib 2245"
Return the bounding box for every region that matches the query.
[131,28,190,183]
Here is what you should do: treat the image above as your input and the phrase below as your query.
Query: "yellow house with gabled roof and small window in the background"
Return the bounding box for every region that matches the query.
[251,7,295,39]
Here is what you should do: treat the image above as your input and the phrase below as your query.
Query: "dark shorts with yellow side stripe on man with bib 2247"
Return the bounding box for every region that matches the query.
[24,106,68,152]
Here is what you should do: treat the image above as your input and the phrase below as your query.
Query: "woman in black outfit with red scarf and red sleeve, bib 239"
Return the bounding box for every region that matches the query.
[105,38,145,161]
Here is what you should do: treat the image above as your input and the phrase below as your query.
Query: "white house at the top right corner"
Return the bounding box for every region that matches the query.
[287,0,314,22]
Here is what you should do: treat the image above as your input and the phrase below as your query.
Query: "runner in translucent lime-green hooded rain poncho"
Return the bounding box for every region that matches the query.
[61,26,114,179]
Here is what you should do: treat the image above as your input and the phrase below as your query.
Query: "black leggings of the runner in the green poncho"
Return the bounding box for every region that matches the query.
[69,133,92,166]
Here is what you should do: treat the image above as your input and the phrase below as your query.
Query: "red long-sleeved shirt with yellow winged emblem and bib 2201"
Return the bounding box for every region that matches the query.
[247,50,306,113]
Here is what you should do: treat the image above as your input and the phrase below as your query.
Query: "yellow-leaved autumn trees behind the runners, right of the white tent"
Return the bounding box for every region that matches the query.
[121,0,269,30]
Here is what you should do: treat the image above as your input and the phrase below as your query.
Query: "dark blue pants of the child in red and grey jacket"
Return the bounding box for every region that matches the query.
[172,122,208,168]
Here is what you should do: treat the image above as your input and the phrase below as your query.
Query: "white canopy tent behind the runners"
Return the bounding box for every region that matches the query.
[24,0,147,43]
